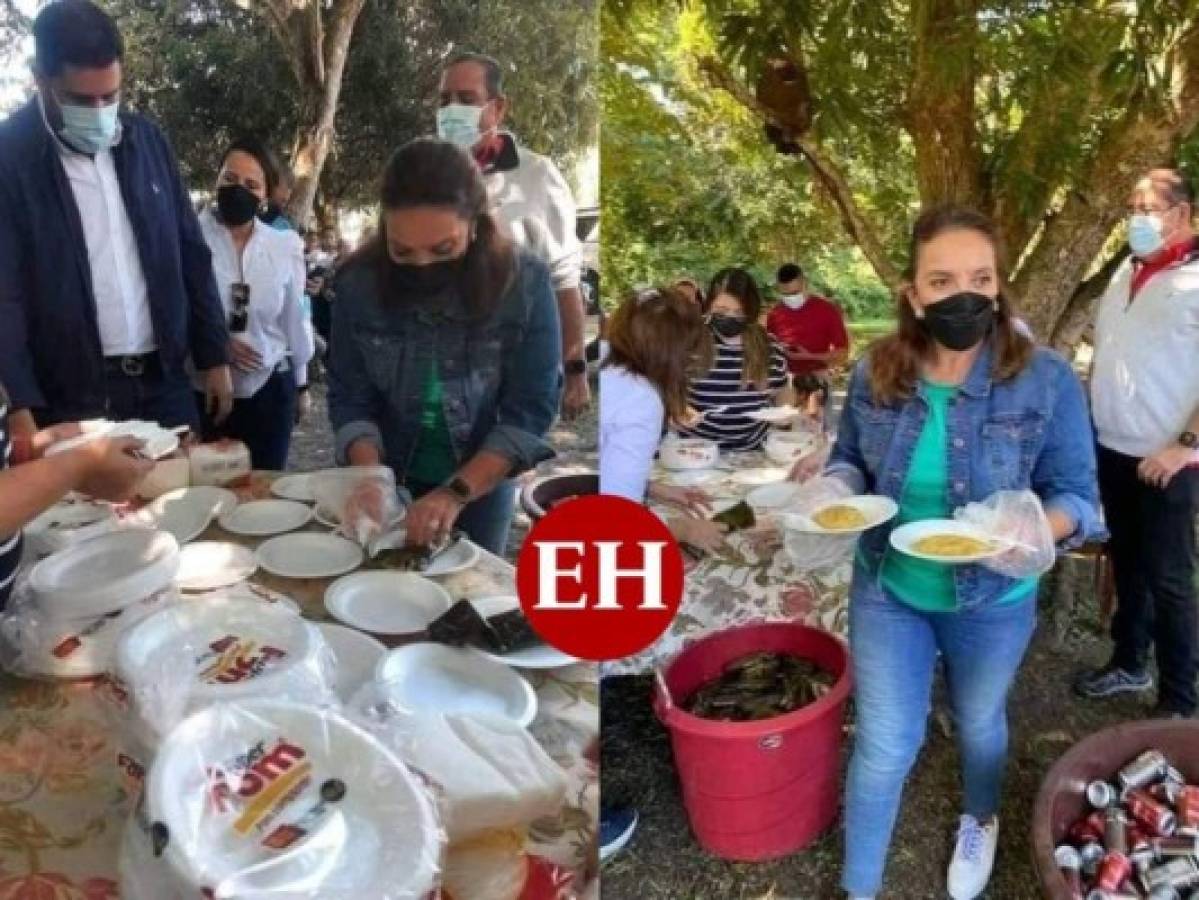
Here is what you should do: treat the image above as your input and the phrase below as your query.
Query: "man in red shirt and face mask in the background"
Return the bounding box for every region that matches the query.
[766,262,849,412]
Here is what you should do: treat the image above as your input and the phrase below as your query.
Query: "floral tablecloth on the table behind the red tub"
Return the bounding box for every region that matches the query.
[604,453,852,675]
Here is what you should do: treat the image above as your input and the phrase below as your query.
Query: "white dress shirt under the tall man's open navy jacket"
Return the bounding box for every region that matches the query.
[43,109,158,356]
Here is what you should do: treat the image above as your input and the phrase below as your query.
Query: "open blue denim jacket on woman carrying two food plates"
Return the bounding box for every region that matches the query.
[826,345,1107,610]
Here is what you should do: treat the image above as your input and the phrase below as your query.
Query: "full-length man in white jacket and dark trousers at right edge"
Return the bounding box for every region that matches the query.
[1076,169,1199,717]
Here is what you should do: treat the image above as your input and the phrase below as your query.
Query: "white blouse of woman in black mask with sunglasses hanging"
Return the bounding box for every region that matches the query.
[194,209,313,399]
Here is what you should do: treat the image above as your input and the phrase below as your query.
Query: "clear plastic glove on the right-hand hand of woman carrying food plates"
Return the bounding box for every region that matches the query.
[953,490,1058,578]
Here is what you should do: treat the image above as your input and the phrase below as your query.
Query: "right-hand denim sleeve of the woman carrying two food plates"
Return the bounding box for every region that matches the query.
[1032,361,1108,550]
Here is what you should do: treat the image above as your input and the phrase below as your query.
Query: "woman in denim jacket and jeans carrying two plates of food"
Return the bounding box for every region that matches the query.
[802,207,1102,900]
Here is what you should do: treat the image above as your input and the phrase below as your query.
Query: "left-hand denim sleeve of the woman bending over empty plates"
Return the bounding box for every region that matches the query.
[326,276,384,465]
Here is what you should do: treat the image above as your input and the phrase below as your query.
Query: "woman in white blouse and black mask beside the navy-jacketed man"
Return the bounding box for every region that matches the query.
[193,139,313,470]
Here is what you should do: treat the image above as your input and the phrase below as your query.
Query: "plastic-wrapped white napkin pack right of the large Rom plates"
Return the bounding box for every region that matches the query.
[351,699,567,844]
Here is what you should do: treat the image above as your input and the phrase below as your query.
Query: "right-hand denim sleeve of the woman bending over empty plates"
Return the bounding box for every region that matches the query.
[480,258,562,475]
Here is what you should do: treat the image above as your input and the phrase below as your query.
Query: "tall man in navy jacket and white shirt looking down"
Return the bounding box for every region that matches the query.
[0,0,233,435]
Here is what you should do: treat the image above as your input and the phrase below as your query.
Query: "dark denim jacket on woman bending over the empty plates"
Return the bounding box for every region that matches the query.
[329,254,561,482]
